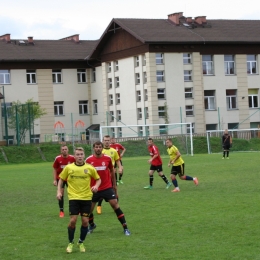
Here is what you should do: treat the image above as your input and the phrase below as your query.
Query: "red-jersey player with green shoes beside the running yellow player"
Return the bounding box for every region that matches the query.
[144,138,172,190]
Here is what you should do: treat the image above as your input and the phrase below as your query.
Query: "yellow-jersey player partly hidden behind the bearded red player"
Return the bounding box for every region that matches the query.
[97,135,122,215]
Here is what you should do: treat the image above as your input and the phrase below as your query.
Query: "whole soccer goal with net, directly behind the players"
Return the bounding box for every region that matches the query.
[100,123,193,156]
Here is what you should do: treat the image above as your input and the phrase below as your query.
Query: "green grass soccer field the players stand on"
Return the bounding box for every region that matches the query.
[0,153,260,260]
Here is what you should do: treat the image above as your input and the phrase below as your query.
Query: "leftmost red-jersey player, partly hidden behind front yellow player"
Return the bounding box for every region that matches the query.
[52,145,75,218]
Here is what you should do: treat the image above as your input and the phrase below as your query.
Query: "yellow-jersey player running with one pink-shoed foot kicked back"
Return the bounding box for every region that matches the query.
[166,139,199,192]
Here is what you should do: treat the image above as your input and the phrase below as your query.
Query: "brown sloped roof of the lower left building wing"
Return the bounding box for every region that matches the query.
[0,39,98,62]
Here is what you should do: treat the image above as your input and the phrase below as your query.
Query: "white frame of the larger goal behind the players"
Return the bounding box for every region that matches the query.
[99,123,193,156]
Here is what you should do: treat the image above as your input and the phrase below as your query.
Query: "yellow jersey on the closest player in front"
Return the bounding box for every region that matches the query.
[59,163,100,200]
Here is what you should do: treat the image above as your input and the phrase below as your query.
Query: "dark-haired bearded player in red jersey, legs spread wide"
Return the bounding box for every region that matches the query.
[86,141,130,236]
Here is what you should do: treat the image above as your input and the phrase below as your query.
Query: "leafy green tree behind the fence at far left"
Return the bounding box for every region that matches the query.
[7,99,47,144]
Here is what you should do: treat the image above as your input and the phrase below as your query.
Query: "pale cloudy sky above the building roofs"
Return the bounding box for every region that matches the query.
[0,0,260,40]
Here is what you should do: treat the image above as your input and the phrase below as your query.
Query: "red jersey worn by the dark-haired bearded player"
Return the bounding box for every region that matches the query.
[86,154,114,191]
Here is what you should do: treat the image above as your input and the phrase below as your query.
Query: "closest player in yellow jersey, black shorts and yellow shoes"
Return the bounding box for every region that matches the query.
[57,147,101,253]
